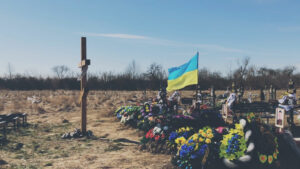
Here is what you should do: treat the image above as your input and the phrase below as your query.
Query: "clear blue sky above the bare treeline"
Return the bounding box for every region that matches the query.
[0,0,300,76]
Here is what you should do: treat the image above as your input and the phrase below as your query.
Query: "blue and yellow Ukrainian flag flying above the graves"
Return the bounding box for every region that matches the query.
[167,53,199,91]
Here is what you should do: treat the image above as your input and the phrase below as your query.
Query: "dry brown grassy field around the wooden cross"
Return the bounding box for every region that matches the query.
[0,90,300,169]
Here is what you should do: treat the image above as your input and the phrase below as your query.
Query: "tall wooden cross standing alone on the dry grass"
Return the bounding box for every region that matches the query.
[78,37,91,135]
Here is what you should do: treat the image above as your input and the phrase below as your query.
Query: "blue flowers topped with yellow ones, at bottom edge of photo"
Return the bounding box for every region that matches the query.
[175,127,214,168]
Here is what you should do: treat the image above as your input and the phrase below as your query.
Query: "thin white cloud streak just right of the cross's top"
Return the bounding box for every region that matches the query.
[83,33,151,40]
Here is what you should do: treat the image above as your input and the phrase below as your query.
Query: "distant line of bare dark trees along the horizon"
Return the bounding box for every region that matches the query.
[0,58,300,90]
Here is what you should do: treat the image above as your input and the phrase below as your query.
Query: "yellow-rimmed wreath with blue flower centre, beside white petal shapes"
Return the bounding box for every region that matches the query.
[219,124,247,161]
